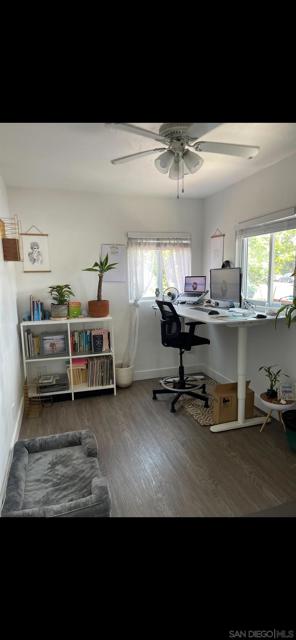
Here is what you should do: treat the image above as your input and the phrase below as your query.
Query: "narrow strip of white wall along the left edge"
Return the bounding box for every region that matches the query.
[0,176,22,508]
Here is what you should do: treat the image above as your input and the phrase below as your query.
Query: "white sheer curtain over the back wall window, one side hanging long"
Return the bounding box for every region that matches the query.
[122,233,191,367]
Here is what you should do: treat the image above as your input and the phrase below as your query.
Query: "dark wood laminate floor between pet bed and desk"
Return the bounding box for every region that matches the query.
[20,380,296,517]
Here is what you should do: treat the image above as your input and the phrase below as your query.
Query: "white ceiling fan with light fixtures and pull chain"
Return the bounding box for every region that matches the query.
[105,122,260,198]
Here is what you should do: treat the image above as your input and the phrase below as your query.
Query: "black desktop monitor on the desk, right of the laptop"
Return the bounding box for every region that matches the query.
[210,267,241,306]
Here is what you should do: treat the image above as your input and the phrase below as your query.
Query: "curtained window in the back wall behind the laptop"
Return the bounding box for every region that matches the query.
[128,233,191,301]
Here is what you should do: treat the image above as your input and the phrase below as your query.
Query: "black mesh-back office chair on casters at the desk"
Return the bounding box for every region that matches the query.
[152,300,210,413]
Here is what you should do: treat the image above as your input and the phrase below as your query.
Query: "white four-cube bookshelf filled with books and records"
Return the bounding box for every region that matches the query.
[20,316,116,400]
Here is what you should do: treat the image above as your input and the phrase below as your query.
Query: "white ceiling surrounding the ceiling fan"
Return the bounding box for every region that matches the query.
[0,123,296,198]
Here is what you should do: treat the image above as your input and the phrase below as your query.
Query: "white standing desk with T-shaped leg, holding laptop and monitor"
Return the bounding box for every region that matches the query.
[176,304,284,432]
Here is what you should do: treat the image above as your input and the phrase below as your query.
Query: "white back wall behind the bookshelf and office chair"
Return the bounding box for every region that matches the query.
[8,189,208,378]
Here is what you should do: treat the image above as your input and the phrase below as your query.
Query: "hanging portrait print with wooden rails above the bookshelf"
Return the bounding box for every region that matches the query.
[21,233,51,273]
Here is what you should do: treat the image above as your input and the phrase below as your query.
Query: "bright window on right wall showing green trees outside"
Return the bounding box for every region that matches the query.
[237,209,296,306]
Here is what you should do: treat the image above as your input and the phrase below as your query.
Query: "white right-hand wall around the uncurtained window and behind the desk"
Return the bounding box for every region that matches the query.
[203,155,296,394]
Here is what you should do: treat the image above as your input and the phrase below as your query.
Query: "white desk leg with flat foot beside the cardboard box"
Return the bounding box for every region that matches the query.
[210,326,265,433]
